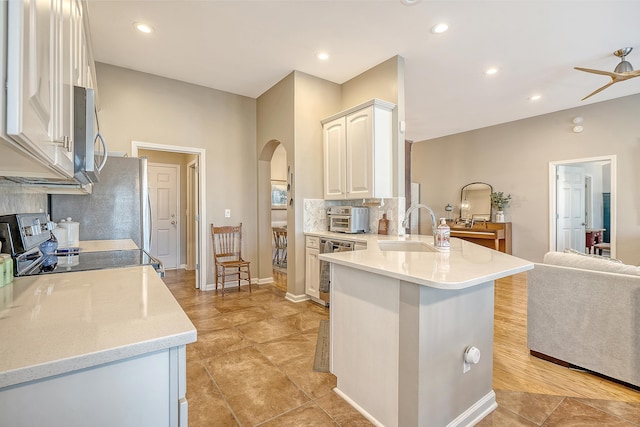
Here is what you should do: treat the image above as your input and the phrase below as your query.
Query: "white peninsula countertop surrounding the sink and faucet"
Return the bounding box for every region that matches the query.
[316,232,533,289]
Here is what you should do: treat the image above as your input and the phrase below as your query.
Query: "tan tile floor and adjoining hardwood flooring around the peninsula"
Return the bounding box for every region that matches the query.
[165,270,640,427]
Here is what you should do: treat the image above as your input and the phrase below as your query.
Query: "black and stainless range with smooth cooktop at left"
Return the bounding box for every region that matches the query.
[0,213,164,276]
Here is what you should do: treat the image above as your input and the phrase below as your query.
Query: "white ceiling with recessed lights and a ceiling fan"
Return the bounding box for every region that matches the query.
[89,0,640,141]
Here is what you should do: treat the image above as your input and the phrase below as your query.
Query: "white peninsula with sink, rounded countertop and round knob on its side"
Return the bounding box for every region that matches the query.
[320,236,533,427]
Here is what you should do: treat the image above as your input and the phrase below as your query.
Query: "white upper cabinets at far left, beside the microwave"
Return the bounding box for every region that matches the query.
[0,0,92,178]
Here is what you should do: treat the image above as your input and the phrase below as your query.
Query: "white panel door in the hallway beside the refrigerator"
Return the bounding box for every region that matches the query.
[149,163,180,269]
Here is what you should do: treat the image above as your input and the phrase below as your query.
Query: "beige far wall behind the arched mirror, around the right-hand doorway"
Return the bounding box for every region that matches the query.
[412,95,640,265]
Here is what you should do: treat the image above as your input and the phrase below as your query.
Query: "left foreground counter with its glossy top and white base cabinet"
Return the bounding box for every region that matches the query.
[0,264,196,427]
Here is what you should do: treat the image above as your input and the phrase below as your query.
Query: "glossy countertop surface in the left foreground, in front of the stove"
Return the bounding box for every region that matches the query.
[0,266,196,388]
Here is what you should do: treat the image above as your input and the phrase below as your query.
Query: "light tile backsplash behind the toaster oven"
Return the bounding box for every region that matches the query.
[303,197,405,235]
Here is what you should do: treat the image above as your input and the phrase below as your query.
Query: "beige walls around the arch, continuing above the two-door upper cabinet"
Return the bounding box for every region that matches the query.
[257,57,404,296]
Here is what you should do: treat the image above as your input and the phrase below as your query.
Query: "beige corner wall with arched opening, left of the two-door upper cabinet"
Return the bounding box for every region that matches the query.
[256,72,340,295]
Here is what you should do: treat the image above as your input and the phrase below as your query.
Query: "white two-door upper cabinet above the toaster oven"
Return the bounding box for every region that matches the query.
[322,99,395,200]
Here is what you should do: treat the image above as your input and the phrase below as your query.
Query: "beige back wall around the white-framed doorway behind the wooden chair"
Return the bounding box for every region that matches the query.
[97,63,258,284]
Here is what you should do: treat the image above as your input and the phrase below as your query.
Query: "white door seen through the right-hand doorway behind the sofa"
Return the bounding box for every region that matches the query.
[556,165,586,252]
